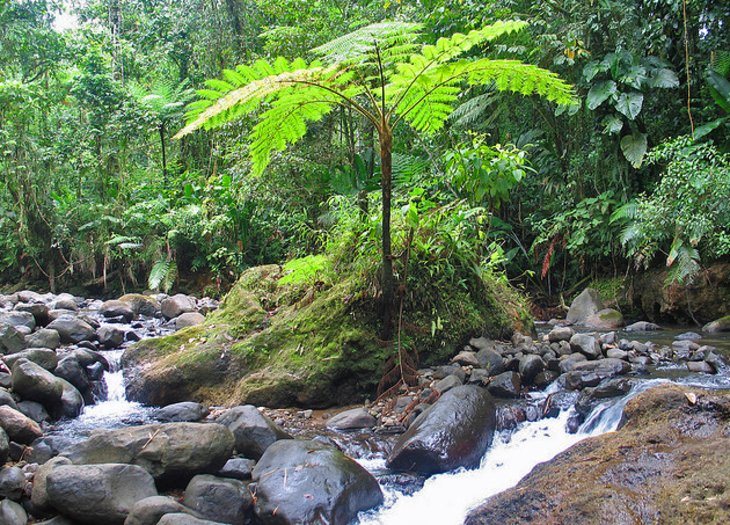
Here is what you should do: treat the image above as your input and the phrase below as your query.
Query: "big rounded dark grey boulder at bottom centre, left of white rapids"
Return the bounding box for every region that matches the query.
[253,438,384,525]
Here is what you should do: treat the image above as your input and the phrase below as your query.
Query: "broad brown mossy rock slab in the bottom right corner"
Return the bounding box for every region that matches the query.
[466,380,730,525]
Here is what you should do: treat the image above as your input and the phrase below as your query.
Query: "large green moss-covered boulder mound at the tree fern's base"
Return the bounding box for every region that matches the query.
[123,256,530,407]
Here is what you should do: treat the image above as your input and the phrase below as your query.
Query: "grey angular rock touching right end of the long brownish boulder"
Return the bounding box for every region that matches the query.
[217,405,291,459]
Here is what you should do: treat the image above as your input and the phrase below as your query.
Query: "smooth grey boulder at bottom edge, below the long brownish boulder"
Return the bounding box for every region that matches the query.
[46,464,157,525]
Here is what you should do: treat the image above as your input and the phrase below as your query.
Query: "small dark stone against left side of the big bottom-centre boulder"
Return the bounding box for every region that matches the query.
[183,474,253,524]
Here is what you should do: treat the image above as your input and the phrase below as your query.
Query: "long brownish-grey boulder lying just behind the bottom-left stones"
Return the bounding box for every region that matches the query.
[64,423,235,487]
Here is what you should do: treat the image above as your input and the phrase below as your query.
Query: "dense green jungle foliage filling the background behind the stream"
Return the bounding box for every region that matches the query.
[0,0,730,302]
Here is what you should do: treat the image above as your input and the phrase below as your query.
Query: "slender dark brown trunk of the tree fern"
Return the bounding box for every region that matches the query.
[380,129,395,341]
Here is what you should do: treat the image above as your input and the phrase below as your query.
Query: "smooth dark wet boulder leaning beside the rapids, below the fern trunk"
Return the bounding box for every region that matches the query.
[387,385,496,474]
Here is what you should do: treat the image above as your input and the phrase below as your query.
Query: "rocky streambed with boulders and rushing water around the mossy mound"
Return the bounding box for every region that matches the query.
[0,286,730,525]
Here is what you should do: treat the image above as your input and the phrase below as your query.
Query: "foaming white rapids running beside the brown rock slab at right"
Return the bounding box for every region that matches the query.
[358,380,661,525]
